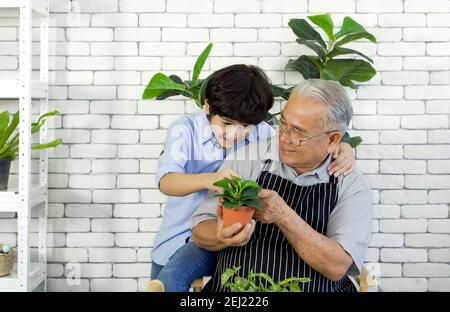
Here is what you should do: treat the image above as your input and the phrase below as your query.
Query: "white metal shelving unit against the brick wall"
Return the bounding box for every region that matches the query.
[0,0,49,292]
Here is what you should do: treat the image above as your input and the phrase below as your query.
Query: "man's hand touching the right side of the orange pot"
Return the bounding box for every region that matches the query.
[254,189,289,224]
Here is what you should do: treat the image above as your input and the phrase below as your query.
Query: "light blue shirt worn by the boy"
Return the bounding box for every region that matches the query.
[152,111,275,265]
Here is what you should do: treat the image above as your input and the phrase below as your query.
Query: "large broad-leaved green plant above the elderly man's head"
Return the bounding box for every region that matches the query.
[280,14,376,89]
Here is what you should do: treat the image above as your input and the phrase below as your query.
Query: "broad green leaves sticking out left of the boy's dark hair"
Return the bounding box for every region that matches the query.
[142,43,213,108]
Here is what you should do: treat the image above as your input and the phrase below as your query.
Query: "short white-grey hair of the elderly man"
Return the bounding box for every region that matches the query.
[291,79,353,132]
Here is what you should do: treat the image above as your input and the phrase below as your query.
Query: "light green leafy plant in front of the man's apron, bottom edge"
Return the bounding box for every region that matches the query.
[220,267,311,292]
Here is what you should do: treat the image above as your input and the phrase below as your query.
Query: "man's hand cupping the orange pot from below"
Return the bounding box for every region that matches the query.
[217,206,256,247]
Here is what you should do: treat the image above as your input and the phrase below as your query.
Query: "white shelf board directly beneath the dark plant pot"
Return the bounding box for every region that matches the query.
[0,185,47,212]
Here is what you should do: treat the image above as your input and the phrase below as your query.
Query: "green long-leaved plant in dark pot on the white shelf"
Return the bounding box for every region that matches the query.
[0,111,62,190]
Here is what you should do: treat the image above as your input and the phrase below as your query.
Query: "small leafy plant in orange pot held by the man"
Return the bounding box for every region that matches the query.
[213,176,262,227]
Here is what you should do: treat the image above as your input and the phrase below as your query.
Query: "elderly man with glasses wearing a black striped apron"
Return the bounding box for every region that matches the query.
[192,79,372,291]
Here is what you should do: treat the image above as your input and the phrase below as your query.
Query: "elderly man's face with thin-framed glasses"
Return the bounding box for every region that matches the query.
[277,94,336,172]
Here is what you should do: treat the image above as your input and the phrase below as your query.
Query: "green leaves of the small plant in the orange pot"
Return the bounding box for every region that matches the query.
[213,176,263,209]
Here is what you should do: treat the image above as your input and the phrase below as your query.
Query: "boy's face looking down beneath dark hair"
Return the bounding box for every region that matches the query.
[205,104,252,148]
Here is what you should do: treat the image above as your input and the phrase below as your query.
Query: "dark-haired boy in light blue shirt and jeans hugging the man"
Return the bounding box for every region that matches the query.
[151,65,354,291]
